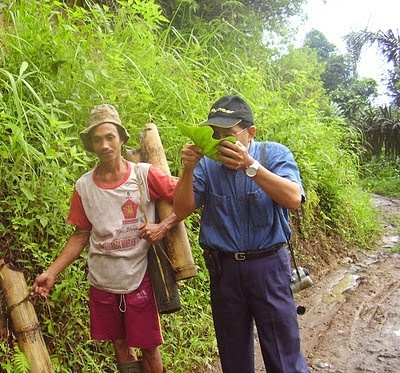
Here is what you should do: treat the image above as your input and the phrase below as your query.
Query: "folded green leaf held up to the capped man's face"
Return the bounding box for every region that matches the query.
[176,124,236,161]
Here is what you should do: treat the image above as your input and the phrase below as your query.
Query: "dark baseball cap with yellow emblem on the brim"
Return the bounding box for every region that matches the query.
[200,95,254,128]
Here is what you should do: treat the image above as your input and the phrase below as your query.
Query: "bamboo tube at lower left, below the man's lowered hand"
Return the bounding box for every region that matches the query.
[0,260,54,373]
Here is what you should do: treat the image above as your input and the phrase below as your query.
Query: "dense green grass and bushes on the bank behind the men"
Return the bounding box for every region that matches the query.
[0,0,392,373]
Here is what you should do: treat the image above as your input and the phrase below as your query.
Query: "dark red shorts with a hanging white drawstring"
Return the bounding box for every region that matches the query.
[89,273,163,349]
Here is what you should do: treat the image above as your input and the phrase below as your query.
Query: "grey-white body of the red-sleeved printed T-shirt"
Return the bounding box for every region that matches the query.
[75,163,155,294]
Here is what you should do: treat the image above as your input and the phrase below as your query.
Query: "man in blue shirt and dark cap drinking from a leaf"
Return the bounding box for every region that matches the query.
[174,95,308,373]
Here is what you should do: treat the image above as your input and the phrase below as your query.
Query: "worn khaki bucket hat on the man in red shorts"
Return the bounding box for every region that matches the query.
[79,104,130,152]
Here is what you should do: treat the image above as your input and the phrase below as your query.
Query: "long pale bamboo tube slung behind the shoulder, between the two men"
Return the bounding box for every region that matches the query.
[136,123,197,281]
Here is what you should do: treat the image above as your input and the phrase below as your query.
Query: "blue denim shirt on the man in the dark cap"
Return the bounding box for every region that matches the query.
[194,140,304,252]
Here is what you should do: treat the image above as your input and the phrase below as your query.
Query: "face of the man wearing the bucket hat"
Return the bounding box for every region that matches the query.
[90,123,123,162]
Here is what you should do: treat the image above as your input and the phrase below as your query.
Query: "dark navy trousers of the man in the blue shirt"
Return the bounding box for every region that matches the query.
[210,248,309,373]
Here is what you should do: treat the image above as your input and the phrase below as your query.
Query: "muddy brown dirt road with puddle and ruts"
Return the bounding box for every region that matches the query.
[294,196,400,373]
